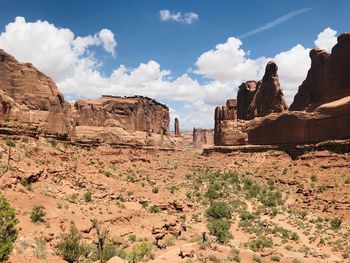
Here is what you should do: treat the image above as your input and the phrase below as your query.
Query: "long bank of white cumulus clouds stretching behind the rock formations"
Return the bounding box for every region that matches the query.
[0,17,335,129]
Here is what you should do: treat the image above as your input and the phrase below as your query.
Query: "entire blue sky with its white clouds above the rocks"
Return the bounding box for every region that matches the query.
[0,0,350,130]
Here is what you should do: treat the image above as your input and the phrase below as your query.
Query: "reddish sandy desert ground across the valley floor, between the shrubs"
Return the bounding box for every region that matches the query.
[0,138,350,263]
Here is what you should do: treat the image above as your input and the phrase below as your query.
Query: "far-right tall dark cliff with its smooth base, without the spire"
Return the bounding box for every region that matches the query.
[248,33,350,144]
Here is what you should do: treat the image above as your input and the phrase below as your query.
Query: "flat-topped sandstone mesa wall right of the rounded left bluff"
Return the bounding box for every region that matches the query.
[73,96,170,134]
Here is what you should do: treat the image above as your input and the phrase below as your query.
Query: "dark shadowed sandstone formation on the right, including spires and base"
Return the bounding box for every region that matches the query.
[214,33,350,146]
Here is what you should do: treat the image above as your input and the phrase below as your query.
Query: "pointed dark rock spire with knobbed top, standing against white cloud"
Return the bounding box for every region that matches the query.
[248,61,288,119]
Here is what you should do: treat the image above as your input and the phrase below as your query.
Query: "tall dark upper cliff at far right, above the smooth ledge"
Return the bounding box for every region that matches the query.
[290,33,350,111]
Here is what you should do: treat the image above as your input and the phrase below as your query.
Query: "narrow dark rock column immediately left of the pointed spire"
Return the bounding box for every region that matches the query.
[237,80,261,120]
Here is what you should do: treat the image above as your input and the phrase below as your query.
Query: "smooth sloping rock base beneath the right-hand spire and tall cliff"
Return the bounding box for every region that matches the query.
[248,96,350,144]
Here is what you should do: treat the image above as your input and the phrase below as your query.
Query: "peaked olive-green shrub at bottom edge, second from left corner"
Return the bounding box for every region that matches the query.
[57,222,85,263]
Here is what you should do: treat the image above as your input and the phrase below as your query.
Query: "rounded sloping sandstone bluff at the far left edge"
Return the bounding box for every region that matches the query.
[0,49,72,133]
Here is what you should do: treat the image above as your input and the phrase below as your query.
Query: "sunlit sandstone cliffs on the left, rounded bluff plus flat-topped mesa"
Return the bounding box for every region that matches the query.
[0,50,181,148]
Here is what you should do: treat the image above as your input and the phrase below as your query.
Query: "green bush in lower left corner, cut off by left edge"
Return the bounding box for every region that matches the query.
[0,194,19,262]
